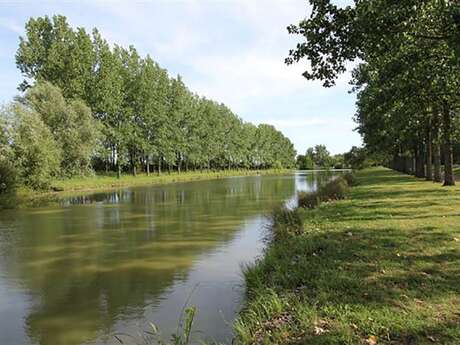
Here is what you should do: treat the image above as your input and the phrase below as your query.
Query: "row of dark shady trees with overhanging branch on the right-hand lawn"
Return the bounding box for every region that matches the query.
[286,0,460,185]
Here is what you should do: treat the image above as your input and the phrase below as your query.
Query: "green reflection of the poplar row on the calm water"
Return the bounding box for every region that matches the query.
[0,177,310,345]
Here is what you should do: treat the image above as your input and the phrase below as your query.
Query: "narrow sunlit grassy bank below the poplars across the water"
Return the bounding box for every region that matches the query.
[8,169,293,209]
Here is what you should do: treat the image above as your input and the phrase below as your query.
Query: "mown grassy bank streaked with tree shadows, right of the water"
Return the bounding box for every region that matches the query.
[235,168,460,344]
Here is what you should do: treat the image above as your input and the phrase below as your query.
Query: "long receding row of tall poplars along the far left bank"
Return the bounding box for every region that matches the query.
[0,16,296,191]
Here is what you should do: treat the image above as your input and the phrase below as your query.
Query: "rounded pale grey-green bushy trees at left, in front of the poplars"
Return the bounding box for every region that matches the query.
[0,82,99,194]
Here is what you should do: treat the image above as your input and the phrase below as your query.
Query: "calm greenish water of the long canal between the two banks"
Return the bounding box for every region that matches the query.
[0,173,328,345]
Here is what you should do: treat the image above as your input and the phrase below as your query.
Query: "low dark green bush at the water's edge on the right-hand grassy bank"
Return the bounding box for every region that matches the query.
[298,176,351,209]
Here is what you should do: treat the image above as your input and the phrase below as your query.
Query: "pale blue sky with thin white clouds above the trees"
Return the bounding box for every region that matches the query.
[0,0,361,154]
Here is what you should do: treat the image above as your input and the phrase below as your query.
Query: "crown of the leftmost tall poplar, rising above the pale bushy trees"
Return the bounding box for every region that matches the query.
[16,16,95,100]
